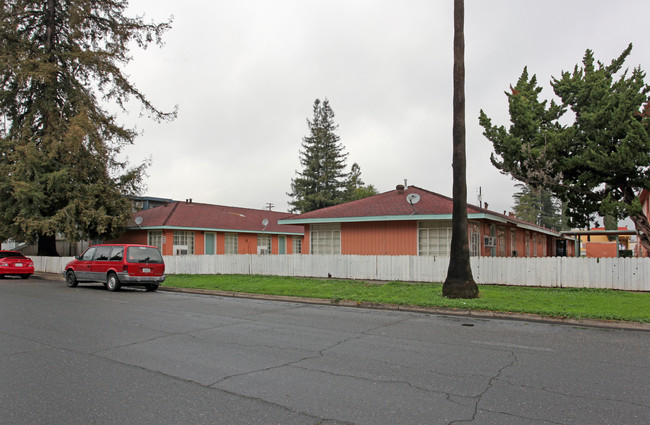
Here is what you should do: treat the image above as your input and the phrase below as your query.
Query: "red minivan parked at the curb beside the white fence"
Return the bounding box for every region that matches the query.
[63,244,165,291]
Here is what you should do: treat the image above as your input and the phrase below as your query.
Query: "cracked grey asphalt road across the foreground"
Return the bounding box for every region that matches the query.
[0,278,650,425]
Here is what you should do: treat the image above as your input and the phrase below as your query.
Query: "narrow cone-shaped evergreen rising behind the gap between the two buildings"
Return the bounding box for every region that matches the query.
[287,99,348,213]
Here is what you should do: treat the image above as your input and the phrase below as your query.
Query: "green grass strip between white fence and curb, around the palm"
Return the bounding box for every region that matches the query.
[165,275,650,323]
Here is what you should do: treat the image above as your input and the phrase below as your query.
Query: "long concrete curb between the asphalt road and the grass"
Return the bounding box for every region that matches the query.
[34,273,650,332]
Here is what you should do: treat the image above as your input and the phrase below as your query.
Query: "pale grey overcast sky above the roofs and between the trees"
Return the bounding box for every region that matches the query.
[117,0,650,219]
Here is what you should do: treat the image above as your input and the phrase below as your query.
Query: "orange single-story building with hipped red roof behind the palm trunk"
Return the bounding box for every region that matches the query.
[278,185,575,257]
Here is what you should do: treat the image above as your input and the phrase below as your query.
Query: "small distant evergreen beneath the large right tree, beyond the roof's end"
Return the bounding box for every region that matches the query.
[513,183,565,230]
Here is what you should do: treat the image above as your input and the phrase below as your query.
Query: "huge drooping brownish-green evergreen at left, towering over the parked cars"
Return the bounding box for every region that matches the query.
[0,0,175,255]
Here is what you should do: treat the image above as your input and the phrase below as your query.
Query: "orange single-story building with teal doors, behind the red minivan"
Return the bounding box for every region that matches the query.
[105,199,303,255]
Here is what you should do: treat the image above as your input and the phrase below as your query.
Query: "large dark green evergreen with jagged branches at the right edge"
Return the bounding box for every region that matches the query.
[479,44,650,250]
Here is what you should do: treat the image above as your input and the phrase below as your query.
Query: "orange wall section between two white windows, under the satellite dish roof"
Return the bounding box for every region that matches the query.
[341,221,418,255]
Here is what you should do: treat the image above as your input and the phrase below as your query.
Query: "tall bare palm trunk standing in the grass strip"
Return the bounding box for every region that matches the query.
[442,0,478,298]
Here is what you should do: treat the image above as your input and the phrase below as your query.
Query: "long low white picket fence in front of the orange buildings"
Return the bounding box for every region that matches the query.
[31,255,650,291]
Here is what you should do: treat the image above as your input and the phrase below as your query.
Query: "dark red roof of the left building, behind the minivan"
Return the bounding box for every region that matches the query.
[128,202,304,235]
